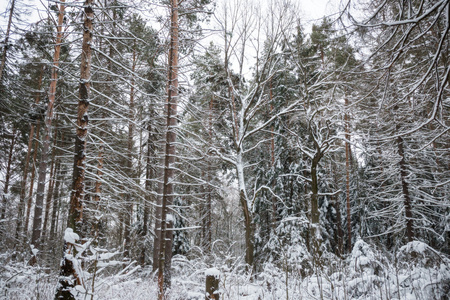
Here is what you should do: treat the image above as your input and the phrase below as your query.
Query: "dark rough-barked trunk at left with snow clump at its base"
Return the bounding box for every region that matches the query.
[55,0,94,299]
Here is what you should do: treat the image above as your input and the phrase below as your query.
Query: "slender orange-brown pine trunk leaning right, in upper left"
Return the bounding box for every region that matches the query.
[31,0,65,248]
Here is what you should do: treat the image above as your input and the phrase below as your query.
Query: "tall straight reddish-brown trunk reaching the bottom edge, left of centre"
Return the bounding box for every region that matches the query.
[158,0,178,300]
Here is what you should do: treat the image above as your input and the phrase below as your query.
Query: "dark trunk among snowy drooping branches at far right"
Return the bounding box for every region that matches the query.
[397,136,414,242]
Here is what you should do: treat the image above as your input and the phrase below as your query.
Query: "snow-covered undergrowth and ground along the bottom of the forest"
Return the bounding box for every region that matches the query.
[0,241,450,300]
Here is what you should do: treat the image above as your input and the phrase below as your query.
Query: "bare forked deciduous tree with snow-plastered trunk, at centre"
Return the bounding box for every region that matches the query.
[210,1,301,268]
